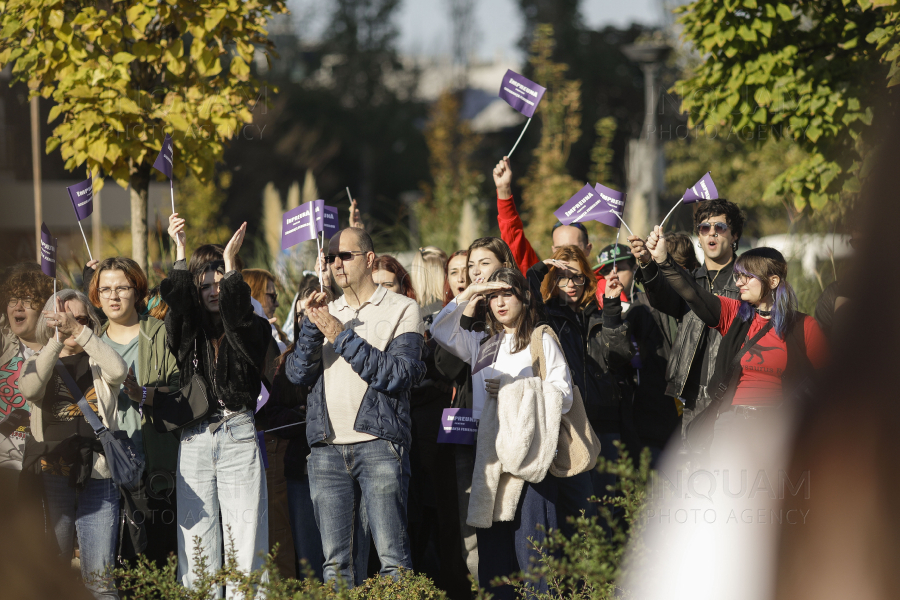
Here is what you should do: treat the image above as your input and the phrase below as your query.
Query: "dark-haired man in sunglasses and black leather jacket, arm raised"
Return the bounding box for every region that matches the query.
[628,199,744,446]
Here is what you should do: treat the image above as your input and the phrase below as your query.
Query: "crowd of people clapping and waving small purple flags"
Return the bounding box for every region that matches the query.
[0,159,833,598]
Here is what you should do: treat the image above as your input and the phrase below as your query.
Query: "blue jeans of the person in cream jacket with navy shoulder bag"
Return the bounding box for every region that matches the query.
[42,473,119,599]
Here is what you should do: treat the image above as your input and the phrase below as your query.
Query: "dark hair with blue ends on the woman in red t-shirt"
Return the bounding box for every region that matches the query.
[734,248,797,339]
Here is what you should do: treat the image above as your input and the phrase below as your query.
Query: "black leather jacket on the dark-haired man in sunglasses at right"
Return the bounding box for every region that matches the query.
[641,255,741,409]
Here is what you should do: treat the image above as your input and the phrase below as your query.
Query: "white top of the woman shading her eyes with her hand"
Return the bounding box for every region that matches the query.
[431,299,573,420]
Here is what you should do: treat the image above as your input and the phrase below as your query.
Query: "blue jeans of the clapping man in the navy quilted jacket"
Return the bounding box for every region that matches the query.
[307,439,412,585]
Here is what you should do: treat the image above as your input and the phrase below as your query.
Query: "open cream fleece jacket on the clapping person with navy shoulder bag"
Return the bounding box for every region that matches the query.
[19,327,128,479]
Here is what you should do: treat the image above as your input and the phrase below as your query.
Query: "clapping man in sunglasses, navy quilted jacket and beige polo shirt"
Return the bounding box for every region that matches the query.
[286,227,425,587]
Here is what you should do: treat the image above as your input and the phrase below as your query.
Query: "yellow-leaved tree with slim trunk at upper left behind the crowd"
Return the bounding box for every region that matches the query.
[0,0,286,268]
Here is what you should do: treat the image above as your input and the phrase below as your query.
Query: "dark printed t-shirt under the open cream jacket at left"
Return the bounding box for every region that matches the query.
[41,352,100,475]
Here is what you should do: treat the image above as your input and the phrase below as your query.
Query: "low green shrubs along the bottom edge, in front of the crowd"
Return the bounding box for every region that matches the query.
[100,443,655,600]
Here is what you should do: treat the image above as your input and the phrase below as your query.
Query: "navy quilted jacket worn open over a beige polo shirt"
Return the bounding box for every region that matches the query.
[286,317,425,450]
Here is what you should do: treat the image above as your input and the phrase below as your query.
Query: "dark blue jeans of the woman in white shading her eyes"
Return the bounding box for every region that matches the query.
[475,474,559,600]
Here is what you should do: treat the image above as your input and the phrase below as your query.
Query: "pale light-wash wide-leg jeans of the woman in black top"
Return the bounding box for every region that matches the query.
[175,412,269,597]
